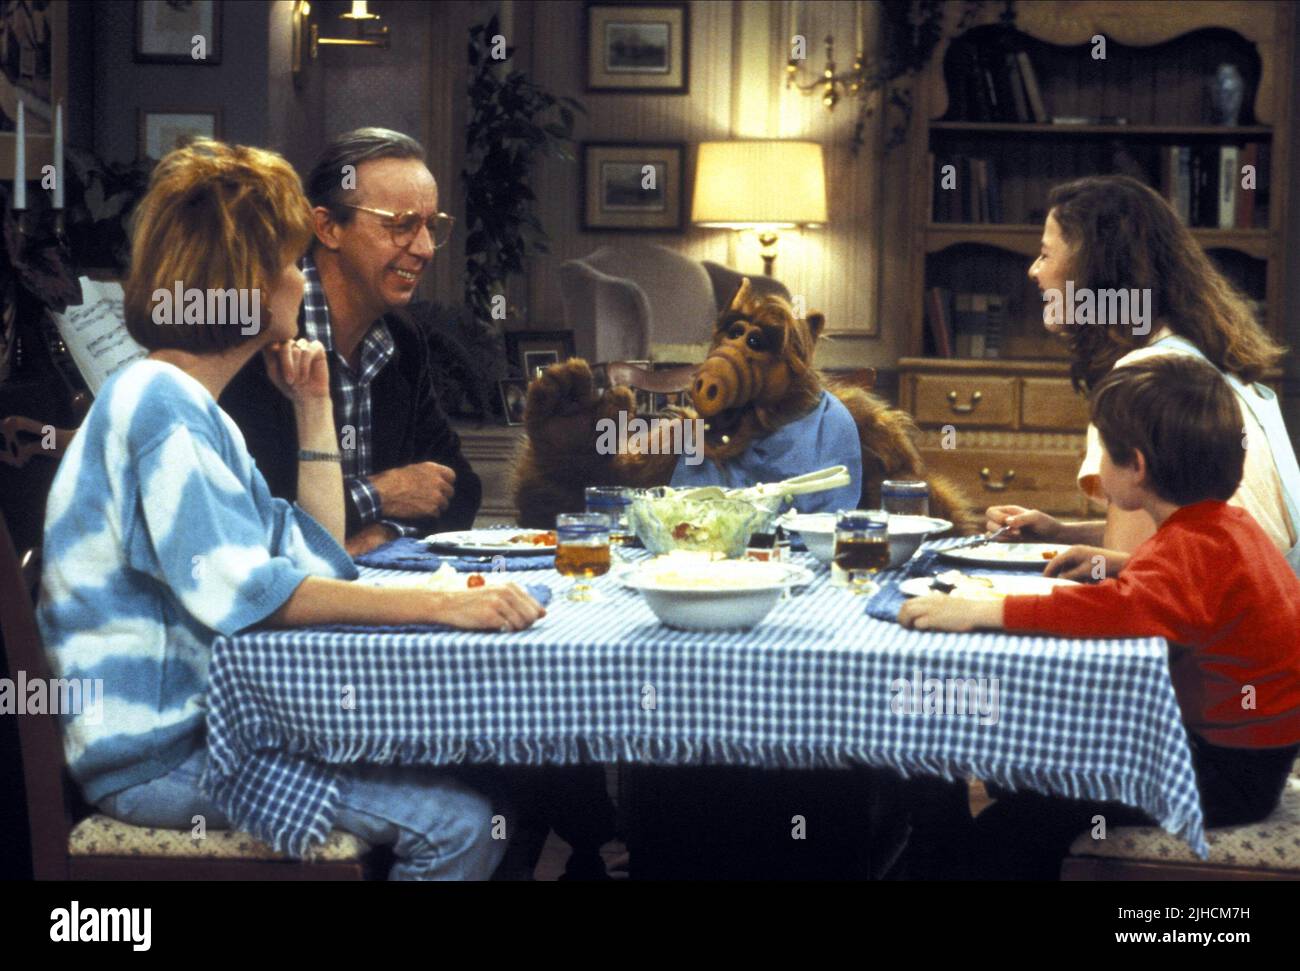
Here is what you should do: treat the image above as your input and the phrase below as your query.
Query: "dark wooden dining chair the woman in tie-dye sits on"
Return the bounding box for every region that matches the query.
[0,517,378,880]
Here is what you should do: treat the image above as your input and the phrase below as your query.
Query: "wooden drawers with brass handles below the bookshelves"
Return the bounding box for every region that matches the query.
[898,357,1099,516]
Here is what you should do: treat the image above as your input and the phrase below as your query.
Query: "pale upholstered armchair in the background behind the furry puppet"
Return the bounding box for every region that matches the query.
[559,243,789,363]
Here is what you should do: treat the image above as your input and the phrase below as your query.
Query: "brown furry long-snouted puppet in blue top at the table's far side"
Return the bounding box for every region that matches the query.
[515,279,974,530]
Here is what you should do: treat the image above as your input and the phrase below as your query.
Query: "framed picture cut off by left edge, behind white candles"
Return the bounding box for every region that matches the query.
[0,3,68,180]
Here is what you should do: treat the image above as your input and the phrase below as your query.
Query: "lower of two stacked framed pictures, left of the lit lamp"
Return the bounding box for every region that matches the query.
[580,142,686,233]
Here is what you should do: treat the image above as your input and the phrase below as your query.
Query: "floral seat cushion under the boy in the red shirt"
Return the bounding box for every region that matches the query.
[1070,773,1300,871]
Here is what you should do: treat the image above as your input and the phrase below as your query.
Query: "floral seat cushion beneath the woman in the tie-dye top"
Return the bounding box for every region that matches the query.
[68,814,371,863]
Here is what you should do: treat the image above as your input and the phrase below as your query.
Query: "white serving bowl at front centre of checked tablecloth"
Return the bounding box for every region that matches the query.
[621,556,811,630]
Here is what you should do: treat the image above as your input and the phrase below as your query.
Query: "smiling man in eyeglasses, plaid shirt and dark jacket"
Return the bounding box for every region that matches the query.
[221,127,482,556]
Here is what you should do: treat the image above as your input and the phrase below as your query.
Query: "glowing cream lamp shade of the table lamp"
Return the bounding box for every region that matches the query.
[690,142,827,229]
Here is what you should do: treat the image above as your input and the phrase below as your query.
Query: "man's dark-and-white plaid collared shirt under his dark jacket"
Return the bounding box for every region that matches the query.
[298,256,403,534]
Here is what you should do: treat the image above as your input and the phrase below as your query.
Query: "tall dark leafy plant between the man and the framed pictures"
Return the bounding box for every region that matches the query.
[460,17,584,326]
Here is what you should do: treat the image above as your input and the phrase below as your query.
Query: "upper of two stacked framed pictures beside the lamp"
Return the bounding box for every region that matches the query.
[584,3,690,95]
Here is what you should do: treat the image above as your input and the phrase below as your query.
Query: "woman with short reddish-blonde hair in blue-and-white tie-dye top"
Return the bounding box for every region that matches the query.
[38,140,543,879]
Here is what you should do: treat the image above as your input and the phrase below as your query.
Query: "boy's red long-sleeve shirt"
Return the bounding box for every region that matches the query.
[1002,500,1300,749]
